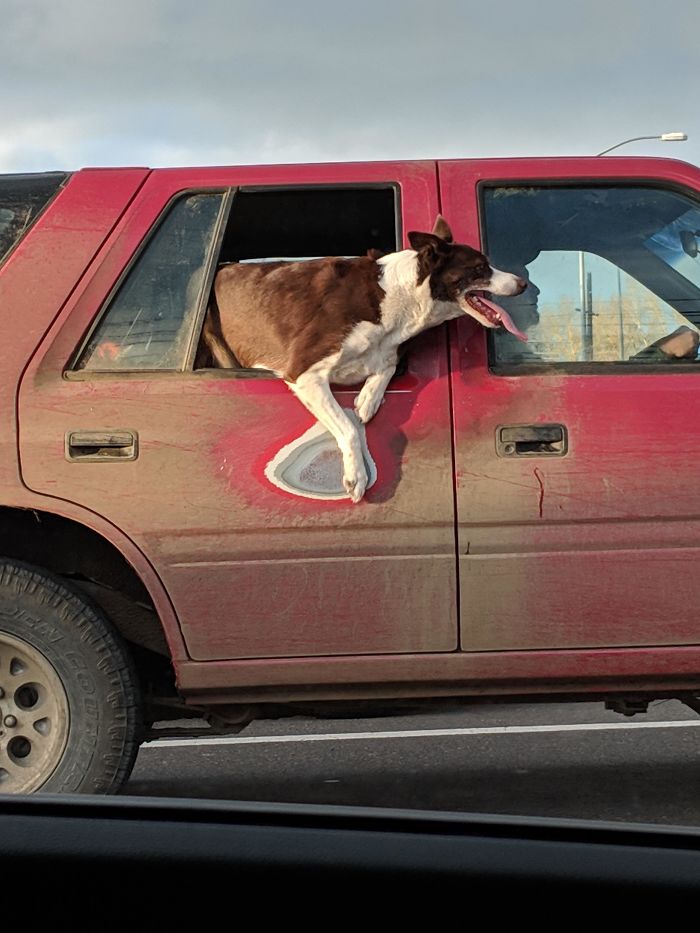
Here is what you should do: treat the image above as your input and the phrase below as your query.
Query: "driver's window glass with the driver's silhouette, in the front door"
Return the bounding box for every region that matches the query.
[485,186,700,364]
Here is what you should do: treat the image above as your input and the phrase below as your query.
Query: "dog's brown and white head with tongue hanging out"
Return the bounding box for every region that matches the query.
[408,215,527,340]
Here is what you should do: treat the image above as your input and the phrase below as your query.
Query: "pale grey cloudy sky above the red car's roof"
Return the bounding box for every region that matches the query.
[0,0,700,172]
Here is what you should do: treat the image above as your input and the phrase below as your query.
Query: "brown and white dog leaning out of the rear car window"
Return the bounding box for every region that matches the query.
[202,216,527,502]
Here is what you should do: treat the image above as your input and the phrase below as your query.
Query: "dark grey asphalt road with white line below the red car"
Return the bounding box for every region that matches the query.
[126,700,700,825]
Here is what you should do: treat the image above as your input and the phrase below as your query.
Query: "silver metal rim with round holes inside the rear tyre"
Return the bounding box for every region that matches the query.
[0,632,70,794]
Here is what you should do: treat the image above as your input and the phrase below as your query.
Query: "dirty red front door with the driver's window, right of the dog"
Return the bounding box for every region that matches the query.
[440,159,700,651]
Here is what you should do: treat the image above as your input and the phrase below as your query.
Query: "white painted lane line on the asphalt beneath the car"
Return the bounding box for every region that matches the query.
[141,719,700,748]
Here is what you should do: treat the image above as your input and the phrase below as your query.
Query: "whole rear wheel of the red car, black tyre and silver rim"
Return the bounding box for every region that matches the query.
[0,559,143,794]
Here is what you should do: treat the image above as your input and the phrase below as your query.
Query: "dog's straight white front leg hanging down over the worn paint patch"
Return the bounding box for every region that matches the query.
[287,372,368,502]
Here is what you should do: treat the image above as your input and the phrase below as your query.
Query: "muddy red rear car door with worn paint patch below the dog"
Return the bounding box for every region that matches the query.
[19,163,457,660]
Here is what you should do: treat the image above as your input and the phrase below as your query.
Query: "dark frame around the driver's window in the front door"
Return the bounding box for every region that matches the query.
[476,175,700,376]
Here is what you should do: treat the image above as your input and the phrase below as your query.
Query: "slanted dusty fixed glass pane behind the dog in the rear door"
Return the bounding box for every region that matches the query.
[77,192,224,370]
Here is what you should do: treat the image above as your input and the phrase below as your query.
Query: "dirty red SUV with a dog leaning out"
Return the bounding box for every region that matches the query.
[0,157,700,793]
